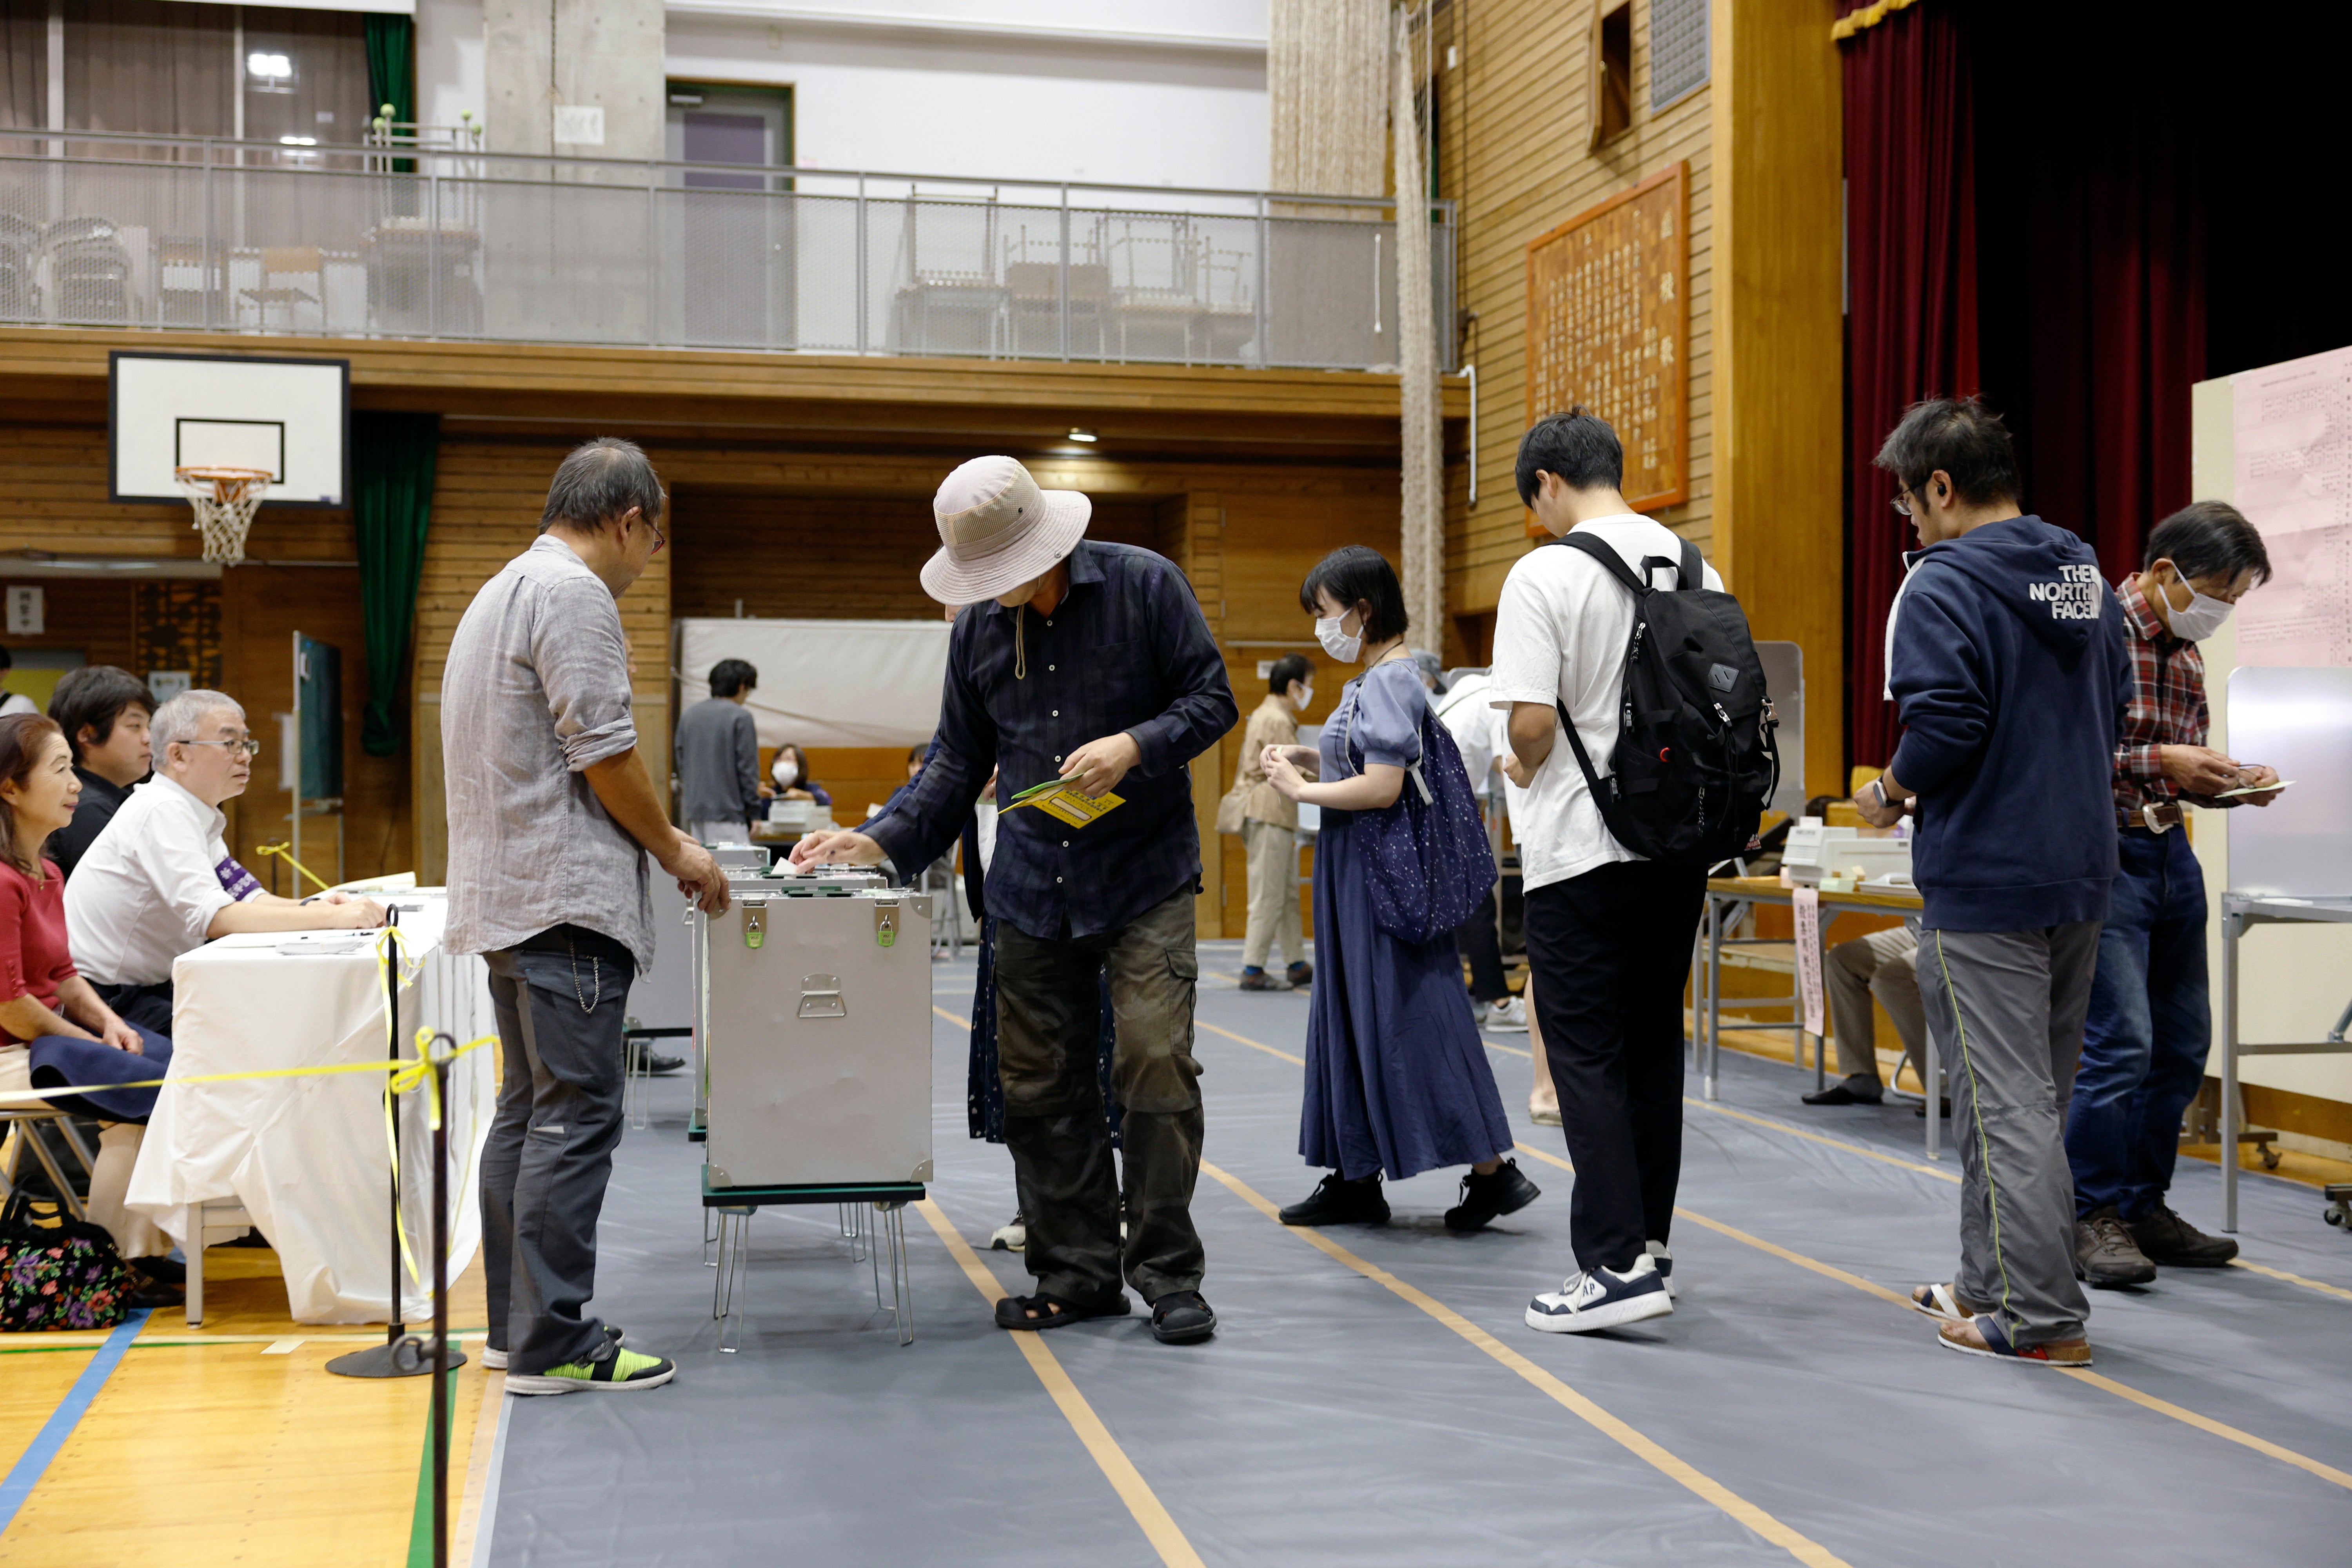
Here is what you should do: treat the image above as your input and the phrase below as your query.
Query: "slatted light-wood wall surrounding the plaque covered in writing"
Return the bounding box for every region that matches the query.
[1437,0,1712,630]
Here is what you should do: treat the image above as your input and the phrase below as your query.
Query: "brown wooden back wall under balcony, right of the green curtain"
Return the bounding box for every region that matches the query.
[414,425,1399,936]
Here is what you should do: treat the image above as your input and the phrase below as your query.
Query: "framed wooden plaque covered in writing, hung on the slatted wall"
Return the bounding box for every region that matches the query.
[1526,162,1691,534]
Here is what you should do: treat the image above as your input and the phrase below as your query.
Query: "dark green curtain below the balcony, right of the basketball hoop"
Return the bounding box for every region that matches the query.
[350,411,440,757]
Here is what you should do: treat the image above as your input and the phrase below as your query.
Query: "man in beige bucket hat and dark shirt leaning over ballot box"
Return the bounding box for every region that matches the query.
[793,456,1240,1345]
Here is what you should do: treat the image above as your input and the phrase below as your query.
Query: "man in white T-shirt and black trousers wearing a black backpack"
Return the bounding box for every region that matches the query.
[1491,409,1771,1333]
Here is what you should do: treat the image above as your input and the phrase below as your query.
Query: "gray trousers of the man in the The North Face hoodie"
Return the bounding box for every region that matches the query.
[1919,919,2100,1347]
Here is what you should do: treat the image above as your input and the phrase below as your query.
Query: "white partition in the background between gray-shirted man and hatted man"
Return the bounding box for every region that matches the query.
[677,616,950,752]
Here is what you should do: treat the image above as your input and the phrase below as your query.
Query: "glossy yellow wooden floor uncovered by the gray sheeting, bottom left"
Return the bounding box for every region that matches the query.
[0,1248,496,1568]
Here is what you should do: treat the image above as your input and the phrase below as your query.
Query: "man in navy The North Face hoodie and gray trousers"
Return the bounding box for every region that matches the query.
[1856,397,2131,1366]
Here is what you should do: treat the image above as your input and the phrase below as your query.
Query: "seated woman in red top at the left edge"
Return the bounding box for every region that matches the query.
[0,712,181,1283]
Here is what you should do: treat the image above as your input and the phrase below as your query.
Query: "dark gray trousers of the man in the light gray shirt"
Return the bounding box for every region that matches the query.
[482,926,635,1373]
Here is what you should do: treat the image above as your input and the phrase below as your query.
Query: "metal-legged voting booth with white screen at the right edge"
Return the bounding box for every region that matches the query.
[2218,665,2352,1232]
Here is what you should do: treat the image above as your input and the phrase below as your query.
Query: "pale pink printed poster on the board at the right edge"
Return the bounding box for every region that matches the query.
[2230,348,2352,665]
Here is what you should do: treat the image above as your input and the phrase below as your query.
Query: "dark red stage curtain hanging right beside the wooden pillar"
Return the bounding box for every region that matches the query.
[1816,0,1978,764]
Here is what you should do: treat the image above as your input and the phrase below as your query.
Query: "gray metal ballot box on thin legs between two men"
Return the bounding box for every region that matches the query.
[694,870,931,1352]
